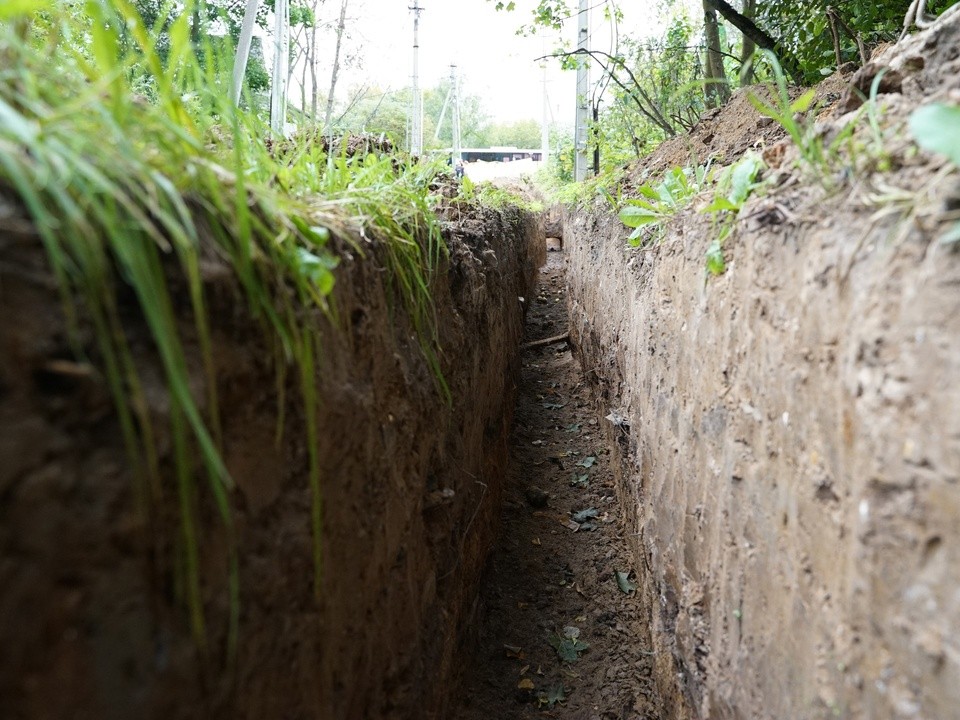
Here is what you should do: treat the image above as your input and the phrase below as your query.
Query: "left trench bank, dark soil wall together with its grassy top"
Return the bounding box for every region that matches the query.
[0,7,544,718]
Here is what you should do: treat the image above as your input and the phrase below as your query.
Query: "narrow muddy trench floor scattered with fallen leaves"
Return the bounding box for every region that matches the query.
[454,251,660,720]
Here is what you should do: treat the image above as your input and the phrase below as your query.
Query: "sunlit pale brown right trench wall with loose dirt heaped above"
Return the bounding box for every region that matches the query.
[565,16,960,718]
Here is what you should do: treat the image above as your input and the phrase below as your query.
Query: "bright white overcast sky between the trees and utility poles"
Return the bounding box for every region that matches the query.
[272,0,688,125]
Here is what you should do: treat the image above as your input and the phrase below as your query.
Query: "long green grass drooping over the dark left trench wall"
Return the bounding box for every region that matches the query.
[0,0,449,658]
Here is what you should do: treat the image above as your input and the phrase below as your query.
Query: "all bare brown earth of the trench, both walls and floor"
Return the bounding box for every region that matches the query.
[0,12,960,720]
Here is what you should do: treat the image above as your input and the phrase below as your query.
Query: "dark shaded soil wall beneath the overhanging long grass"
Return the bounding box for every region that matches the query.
[0,200,544,720]
